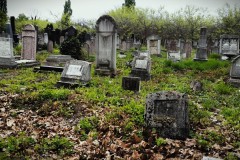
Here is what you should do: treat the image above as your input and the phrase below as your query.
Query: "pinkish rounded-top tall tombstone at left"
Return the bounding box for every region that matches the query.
[21,24,37,60]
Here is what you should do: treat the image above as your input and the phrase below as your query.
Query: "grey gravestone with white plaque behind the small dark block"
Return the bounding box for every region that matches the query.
[130,56,151,81]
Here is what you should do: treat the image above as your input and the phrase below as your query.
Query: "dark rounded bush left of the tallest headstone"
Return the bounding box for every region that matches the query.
[60,37,83,59]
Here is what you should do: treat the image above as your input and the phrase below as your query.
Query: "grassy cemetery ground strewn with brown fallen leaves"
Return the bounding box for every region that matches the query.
[0,51,240,159]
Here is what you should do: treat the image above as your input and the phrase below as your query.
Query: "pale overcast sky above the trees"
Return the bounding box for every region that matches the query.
[7,0,240,21]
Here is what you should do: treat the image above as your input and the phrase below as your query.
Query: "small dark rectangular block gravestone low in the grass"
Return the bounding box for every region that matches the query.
[122,77,141,92]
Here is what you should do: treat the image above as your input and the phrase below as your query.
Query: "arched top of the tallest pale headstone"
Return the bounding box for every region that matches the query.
[96,15,117,33]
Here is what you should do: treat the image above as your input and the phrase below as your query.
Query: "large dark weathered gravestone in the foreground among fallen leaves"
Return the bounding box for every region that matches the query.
[144,91,189,139]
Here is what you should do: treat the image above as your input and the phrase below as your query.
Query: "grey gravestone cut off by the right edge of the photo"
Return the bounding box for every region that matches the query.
[229,55,240,87]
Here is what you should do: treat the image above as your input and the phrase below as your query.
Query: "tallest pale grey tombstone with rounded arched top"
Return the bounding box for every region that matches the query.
[95,15,117,75]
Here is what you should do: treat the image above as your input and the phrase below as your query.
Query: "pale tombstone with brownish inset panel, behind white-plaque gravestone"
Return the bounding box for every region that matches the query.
[147,35,161,56]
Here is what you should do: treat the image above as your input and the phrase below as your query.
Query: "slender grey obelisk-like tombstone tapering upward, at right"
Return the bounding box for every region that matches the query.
[194,27,208,61]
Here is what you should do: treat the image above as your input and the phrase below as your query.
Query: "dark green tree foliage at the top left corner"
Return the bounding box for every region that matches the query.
[0,0,7,31]
